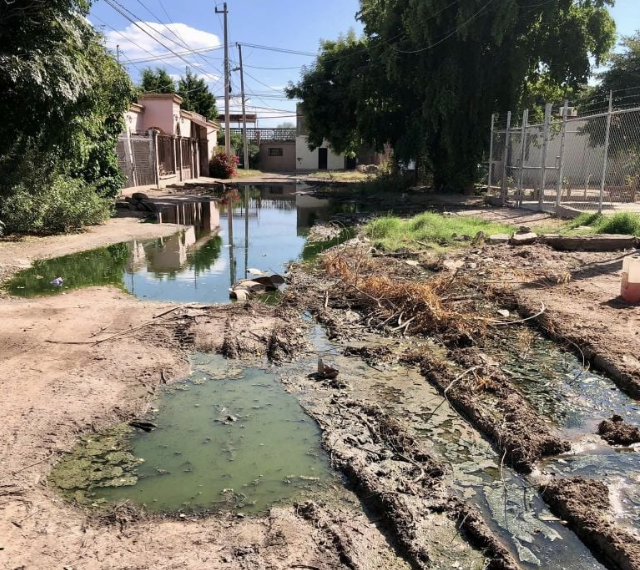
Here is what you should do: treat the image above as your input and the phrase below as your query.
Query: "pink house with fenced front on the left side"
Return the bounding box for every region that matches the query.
[117,93,220,188]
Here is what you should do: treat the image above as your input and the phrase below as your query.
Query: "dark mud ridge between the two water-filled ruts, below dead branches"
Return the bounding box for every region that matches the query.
[416,349,571,473]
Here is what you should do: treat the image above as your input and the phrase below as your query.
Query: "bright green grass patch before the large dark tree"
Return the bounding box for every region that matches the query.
[364,212,516,251]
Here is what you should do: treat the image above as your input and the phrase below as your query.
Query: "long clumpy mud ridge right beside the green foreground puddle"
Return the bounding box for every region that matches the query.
[313,396,518,570]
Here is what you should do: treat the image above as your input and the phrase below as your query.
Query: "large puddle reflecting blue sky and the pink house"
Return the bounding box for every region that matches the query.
[5,184,357,303]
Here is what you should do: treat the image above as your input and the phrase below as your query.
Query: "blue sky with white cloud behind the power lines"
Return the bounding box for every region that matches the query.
[89,0,640,127]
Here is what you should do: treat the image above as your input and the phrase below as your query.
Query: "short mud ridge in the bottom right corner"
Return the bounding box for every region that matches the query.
[541,477,640,570]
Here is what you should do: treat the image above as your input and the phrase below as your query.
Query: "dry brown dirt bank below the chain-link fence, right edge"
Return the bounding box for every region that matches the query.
[479,245,640,399]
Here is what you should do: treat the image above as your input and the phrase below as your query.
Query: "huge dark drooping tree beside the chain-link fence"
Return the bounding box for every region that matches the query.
[288,0,615,190]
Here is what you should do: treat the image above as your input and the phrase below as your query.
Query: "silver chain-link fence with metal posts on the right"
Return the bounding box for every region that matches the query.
[487,100,640,212]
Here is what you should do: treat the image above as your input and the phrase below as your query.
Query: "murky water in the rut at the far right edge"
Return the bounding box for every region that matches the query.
[495,332,640,537]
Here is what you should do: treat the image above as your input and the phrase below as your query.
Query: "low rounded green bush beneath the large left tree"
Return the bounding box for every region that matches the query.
[1,176,111,234]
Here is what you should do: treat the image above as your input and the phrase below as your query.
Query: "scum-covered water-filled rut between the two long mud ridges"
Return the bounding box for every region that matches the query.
[304,327,604,570]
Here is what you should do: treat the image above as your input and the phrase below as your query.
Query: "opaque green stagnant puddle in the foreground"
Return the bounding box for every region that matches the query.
[65,354,340,513]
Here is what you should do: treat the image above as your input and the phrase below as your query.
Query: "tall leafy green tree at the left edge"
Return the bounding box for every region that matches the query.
[0,0,134,231]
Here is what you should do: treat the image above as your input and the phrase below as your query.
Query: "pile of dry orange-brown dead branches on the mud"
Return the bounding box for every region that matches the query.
[323,248,487,345]
